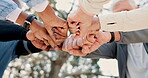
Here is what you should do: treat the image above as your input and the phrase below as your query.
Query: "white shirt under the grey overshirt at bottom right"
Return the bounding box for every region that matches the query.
[126,43,148,78]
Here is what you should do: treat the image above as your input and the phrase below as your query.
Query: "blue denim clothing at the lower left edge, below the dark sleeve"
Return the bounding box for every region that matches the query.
[0,40,19,78]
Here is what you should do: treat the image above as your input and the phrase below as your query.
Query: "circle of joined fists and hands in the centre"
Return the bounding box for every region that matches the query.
[26,9,110,56]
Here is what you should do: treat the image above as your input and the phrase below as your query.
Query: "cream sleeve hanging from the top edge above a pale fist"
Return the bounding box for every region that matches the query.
[79,0,110,15]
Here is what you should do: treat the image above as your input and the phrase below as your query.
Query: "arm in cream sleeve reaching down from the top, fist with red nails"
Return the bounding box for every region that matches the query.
[67,0,109,38]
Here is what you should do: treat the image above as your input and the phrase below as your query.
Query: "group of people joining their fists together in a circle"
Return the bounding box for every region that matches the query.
[0,0,148,78]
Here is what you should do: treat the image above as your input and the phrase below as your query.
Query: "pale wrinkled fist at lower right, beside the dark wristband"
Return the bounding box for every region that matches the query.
[62,31,110,56]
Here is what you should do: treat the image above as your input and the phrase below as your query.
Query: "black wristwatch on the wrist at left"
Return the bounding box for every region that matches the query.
[24,14,37,30]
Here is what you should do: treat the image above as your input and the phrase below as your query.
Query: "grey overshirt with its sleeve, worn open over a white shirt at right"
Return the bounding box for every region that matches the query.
[85,30,148,78]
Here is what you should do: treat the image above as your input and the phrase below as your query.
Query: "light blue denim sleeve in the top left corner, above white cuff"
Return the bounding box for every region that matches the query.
[0,0,17,20]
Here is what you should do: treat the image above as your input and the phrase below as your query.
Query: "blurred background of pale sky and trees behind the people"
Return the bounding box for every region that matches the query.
[3,0,147,78]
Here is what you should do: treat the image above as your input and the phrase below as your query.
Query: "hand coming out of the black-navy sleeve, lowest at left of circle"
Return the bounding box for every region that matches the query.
[26,30,50,51]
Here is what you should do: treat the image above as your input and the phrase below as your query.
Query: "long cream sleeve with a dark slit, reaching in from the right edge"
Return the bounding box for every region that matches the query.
[99,5,148,32]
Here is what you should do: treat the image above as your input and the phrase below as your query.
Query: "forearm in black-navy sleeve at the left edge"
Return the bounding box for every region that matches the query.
[0,21,28,41]
